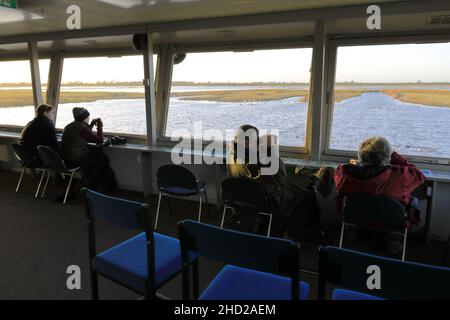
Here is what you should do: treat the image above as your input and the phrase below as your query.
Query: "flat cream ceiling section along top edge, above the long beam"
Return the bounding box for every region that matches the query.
[0,0,408,37]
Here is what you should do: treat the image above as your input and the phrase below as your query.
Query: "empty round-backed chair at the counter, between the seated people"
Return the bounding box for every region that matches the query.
[155,164,208,230]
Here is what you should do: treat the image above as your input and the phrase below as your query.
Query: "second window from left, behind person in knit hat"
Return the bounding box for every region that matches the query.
[56,55,156,135]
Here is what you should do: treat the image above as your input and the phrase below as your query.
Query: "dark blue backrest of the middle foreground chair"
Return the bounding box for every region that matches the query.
[178,220,300,299]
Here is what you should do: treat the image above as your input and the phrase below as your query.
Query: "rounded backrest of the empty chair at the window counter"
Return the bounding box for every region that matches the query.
[156,164,197,191]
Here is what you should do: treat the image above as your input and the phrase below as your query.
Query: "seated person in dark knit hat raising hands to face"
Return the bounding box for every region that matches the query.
[62,108,117,192]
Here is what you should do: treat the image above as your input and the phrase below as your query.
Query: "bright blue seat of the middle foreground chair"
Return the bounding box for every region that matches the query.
[200,265,309,300]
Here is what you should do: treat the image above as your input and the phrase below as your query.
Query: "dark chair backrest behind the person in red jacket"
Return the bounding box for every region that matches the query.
[343,194,405,232]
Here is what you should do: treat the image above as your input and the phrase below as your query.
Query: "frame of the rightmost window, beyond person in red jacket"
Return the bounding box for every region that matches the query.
[321,34,450,167]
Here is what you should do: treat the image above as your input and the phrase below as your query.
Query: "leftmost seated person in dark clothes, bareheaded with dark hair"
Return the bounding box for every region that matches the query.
[19,104,58,163]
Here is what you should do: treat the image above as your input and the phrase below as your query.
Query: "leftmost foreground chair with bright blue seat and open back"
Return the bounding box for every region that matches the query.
[81,188,194,300]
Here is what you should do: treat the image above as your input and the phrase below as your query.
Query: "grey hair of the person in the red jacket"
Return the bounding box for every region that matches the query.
[358,137,392,167]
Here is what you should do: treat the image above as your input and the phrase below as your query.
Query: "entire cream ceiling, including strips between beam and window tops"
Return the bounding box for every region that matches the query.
[0,0,450,59]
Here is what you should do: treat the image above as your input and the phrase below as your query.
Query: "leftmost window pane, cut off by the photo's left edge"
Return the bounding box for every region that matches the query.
[0,60,50,126]
